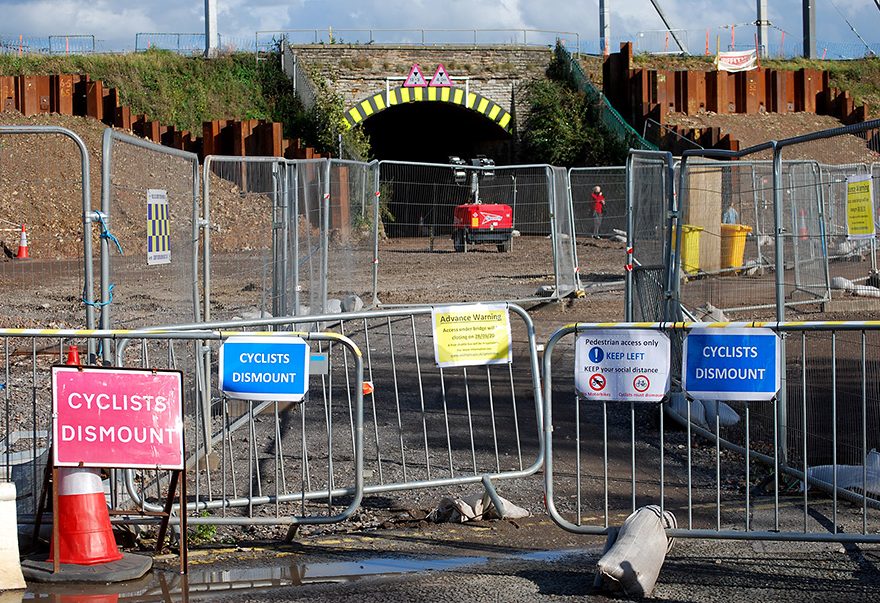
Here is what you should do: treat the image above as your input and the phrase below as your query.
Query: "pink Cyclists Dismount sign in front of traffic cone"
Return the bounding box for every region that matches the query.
[52,366,183,469]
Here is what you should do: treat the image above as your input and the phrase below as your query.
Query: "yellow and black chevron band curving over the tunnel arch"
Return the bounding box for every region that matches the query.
[345,86,511,132]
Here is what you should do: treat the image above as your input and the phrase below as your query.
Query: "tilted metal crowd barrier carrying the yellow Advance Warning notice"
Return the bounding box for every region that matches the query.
[140,304,544,509]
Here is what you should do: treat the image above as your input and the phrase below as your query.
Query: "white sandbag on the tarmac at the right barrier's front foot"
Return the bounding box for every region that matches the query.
[597,505,676,597]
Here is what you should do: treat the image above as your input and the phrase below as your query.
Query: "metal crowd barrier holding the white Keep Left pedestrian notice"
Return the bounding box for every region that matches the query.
[543,321,880,542]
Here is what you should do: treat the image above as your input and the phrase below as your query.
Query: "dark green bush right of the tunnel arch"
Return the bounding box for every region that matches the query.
[521,57,627,167]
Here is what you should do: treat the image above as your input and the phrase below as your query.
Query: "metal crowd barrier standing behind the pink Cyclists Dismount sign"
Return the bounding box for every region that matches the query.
[0,329,364,525]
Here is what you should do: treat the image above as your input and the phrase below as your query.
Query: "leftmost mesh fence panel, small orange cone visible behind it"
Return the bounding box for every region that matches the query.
[0,126,94,327]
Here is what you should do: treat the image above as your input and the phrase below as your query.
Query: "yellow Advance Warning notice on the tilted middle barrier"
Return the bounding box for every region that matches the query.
[431,304,510,366]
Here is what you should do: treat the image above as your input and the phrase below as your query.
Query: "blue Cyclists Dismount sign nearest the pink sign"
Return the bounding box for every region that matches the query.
[219,335,309,402]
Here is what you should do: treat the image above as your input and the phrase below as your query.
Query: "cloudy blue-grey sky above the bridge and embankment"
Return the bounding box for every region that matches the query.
[0,0,880,57]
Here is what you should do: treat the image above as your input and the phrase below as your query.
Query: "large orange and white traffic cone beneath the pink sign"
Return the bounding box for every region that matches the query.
[49,467,122,565]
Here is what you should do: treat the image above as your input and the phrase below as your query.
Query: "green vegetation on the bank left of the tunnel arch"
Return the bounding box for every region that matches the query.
[0,50,369,158]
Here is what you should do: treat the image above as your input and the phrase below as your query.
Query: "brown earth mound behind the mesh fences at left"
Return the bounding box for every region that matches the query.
[0,112,271,261]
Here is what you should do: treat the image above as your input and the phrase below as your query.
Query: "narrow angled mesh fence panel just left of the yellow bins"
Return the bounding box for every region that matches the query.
[621,155,671,321]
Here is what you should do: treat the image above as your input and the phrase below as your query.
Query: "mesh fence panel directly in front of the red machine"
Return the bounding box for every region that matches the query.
[378,161,574,304]
